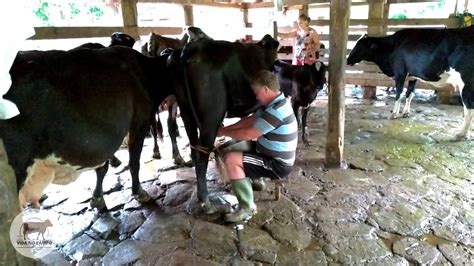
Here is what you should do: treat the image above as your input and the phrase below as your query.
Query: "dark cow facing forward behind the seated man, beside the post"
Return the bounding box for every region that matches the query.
[273,60,326,147]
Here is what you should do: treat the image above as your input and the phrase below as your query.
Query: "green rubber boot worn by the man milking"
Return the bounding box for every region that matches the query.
[225,178,257,223]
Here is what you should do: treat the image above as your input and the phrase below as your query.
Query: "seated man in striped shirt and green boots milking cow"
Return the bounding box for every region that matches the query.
[217,70,298,222]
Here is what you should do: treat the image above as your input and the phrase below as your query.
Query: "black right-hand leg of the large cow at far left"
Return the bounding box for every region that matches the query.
[128,123,151,203]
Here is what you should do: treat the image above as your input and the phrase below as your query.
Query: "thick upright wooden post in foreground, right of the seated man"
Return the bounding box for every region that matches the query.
[326,0,351,167]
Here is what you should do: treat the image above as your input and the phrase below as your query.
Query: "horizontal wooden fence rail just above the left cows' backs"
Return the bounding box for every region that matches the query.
[29,27,183,40]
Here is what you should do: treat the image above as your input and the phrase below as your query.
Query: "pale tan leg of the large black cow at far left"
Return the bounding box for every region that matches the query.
[18,160,55,208]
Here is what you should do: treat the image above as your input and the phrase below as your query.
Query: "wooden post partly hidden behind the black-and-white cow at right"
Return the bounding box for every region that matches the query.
[363,0,388,100]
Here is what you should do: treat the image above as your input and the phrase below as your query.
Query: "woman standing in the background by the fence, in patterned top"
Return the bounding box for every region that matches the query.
[278,14,320,65]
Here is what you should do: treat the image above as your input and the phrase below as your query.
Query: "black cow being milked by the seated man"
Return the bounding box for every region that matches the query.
[169,35,279,212]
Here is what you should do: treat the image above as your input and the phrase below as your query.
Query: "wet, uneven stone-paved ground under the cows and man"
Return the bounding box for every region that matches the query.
[35,87,474,265]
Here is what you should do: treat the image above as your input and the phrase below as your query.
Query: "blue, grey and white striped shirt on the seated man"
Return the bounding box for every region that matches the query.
[253,93,298,165]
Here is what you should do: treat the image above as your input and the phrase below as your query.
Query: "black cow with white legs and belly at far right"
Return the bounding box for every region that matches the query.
[347,26,474,140]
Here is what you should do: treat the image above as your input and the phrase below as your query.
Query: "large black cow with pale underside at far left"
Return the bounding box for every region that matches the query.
[0,46,172,211]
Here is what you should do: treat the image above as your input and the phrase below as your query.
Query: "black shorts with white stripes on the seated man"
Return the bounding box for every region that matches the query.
[242,152,293,180]
